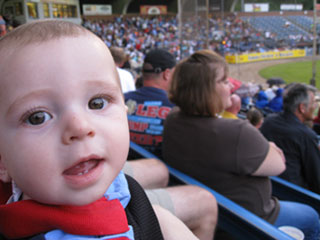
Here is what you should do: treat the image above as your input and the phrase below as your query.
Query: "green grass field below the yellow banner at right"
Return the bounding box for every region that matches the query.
[259,61,320,89]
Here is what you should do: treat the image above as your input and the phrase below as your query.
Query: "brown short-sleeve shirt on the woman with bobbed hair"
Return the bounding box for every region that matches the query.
[163,111,279,223]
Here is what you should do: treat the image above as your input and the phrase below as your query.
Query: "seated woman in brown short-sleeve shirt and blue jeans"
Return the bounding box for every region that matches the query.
[163,50,320,239]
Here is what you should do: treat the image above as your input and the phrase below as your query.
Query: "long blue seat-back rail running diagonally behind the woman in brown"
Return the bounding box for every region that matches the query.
[130,142,293,240]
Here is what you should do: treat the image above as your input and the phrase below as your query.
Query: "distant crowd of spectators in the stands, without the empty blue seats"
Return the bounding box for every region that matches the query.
[83,15,312,69]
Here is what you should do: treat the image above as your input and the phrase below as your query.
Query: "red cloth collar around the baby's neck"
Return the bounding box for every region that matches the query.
[0,184,129,239]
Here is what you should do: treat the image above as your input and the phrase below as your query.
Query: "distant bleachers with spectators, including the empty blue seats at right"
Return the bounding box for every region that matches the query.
[83,14,320,60]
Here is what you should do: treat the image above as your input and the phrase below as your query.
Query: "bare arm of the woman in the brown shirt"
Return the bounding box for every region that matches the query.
[252,142,286,176]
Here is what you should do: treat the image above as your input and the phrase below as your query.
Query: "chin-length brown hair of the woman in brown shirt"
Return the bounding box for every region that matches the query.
[169,50,228,117]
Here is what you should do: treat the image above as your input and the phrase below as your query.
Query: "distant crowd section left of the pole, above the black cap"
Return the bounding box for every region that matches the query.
[83,16,179,69]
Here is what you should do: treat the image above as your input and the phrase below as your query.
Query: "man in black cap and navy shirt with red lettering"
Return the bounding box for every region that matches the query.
[125,49,176,158]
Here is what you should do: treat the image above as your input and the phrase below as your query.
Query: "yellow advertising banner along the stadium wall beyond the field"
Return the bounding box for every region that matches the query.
[225,49,306,64]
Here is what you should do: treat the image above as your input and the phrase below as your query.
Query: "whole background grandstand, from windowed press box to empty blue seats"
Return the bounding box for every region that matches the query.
[0,0,320,58]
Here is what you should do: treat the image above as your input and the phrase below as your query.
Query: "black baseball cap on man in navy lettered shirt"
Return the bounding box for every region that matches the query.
[142,48,176,73]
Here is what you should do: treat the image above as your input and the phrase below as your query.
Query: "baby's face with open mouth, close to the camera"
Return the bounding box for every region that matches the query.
[0,36,129,205]
